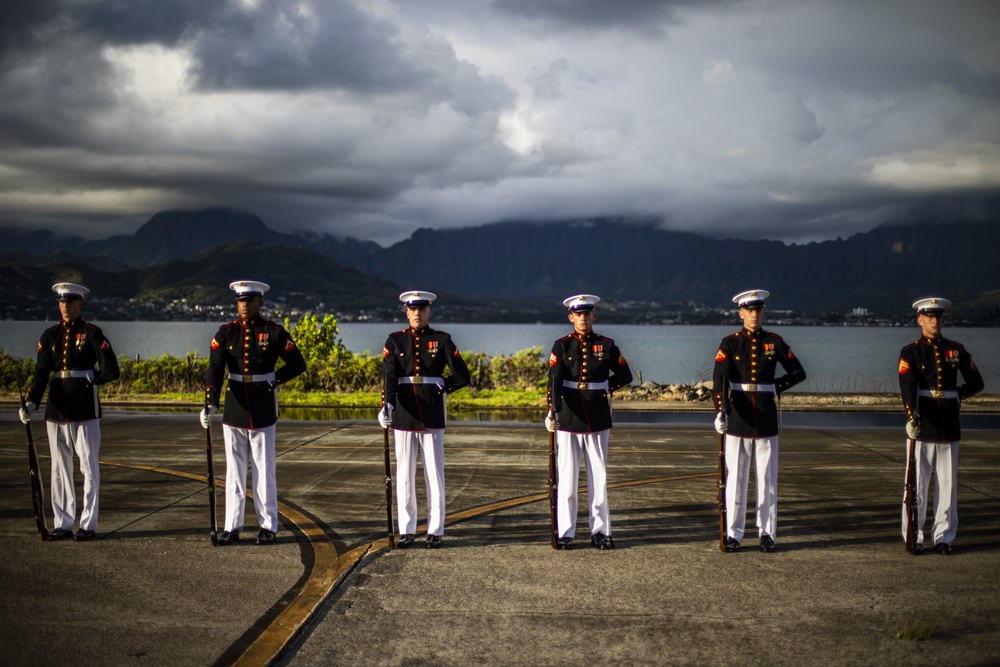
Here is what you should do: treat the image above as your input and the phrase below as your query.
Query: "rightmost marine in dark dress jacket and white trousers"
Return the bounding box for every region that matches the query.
[899,297,985,555]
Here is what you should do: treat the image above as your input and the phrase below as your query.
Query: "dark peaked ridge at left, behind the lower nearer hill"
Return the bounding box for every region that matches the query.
[0,207,379,268]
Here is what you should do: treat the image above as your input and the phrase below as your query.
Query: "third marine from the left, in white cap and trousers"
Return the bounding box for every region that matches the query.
[379,291,470,549]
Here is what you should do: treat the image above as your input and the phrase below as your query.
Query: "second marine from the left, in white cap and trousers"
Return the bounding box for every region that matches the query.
[200,280,306,546]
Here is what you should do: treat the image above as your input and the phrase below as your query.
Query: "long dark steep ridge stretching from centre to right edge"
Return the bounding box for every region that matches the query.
[356,220,1000,312]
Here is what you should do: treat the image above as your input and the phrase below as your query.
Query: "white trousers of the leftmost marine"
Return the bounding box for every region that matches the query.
[45,419,101,530]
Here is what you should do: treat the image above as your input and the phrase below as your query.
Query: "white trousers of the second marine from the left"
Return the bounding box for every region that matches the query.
[222,424,278,533]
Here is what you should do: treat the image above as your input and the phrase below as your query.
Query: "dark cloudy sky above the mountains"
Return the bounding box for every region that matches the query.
[0,0,1000,244]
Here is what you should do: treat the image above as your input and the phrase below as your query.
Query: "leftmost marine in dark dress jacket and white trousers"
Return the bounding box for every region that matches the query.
[21,283,119,541]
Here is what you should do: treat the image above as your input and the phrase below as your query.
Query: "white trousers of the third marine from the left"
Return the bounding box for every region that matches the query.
[393,428,445,536]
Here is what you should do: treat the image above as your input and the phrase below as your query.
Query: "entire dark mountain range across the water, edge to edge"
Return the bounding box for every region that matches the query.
[0,208,1000,322]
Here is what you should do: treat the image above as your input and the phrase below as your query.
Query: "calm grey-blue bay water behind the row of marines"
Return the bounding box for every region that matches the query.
[0,320,1000,393]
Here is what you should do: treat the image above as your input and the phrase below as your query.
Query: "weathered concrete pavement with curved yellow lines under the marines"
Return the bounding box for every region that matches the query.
[0,410,1000,665]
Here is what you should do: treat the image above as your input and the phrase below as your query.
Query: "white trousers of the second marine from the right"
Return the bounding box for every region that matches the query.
[726,435,778,542]
